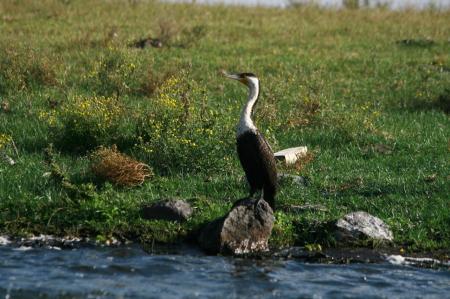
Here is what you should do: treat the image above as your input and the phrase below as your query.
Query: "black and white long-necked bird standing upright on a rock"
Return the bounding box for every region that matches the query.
[224,72,277,210]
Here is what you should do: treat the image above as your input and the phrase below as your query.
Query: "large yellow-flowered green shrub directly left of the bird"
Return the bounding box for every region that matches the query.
[137,72,234,172]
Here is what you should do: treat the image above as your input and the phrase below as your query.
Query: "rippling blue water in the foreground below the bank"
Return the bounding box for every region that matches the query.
[0,246,450,299]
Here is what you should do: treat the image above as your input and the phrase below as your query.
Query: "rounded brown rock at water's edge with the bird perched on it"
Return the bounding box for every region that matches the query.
[198,198,275,255]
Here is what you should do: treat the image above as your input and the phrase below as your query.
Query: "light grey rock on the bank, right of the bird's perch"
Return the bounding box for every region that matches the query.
[335,211,394,243]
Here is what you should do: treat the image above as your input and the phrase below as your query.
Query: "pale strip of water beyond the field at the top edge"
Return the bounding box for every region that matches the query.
[163,0,450,10]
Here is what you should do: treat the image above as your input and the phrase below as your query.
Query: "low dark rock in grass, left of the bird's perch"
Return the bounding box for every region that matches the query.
[141,199,192,222]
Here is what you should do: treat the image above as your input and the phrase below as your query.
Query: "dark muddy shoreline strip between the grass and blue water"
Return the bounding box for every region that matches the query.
[0,235,450,269]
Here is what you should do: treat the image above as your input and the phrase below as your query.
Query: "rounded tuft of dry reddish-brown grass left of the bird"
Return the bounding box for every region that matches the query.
[91,145,152,187]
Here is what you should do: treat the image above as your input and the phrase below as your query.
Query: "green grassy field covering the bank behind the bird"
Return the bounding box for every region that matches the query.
[0,0,450,251]
